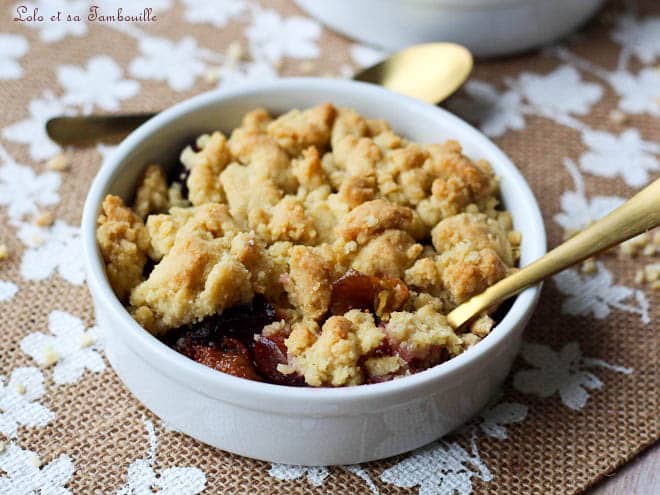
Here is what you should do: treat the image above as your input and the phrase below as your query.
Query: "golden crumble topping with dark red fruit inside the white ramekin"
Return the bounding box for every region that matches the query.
[97,103,520,387]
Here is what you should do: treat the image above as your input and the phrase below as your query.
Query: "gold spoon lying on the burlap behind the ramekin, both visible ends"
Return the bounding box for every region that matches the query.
[46,43,472,146]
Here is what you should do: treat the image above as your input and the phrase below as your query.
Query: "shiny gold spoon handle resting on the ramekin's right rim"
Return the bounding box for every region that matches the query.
[447,179,660,328]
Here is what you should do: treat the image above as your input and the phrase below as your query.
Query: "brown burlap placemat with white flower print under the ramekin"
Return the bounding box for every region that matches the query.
[0,0,660,495]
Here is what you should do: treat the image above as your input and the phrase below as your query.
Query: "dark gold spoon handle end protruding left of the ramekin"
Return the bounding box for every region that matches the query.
[46,113,156,146]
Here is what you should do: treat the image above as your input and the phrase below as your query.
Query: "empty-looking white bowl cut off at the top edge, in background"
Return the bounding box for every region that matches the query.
[295,0,603,57]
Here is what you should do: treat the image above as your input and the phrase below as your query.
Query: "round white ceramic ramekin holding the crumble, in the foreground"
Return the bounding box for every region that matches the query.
[82,78,545,465]
